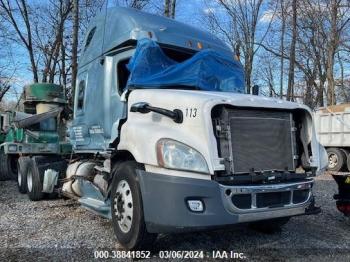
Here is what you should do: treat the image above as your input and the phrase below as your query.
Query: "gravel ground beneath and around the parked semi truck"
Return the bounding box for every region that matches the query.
[0,175,350,261]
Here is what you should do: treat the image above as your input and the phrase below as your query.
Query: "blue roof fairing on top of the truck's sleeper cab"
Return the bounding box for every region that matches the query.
[79,7,233,67]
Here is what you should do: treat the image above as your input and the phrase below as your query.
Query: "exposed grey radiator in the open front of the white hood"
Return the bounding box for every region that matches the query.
[216,109,294,174]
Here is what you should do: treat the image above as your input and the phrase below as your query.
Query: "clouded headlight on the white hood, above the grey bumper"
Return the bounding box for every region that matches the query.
[157,138,209,173]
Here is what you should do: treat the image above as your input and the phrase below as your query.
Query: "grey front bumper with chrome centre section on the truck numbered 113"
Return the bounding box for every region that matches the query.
[137,170,313,233]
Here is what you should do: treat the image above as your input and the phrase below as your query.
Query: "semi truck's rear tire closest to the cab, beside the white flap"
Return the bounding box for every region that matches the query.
[27,159,44,201]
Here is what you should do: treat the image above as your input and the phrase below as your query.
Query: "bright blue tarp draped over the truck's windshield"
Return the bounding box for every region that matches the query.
[127,39,245,93]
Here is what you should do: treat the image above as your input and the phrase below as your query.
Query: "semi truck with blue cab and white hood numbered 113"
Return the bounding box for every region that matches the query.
[21,8,327,249]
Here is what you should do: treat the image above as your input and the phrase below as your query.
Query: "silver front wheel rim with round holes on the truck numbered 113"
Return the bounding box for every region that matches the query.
[114,180,134,233]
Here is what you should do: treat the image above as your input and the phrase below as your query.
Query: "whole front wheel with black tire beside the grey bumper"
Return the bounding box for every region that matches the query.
[111,161,157,250]
